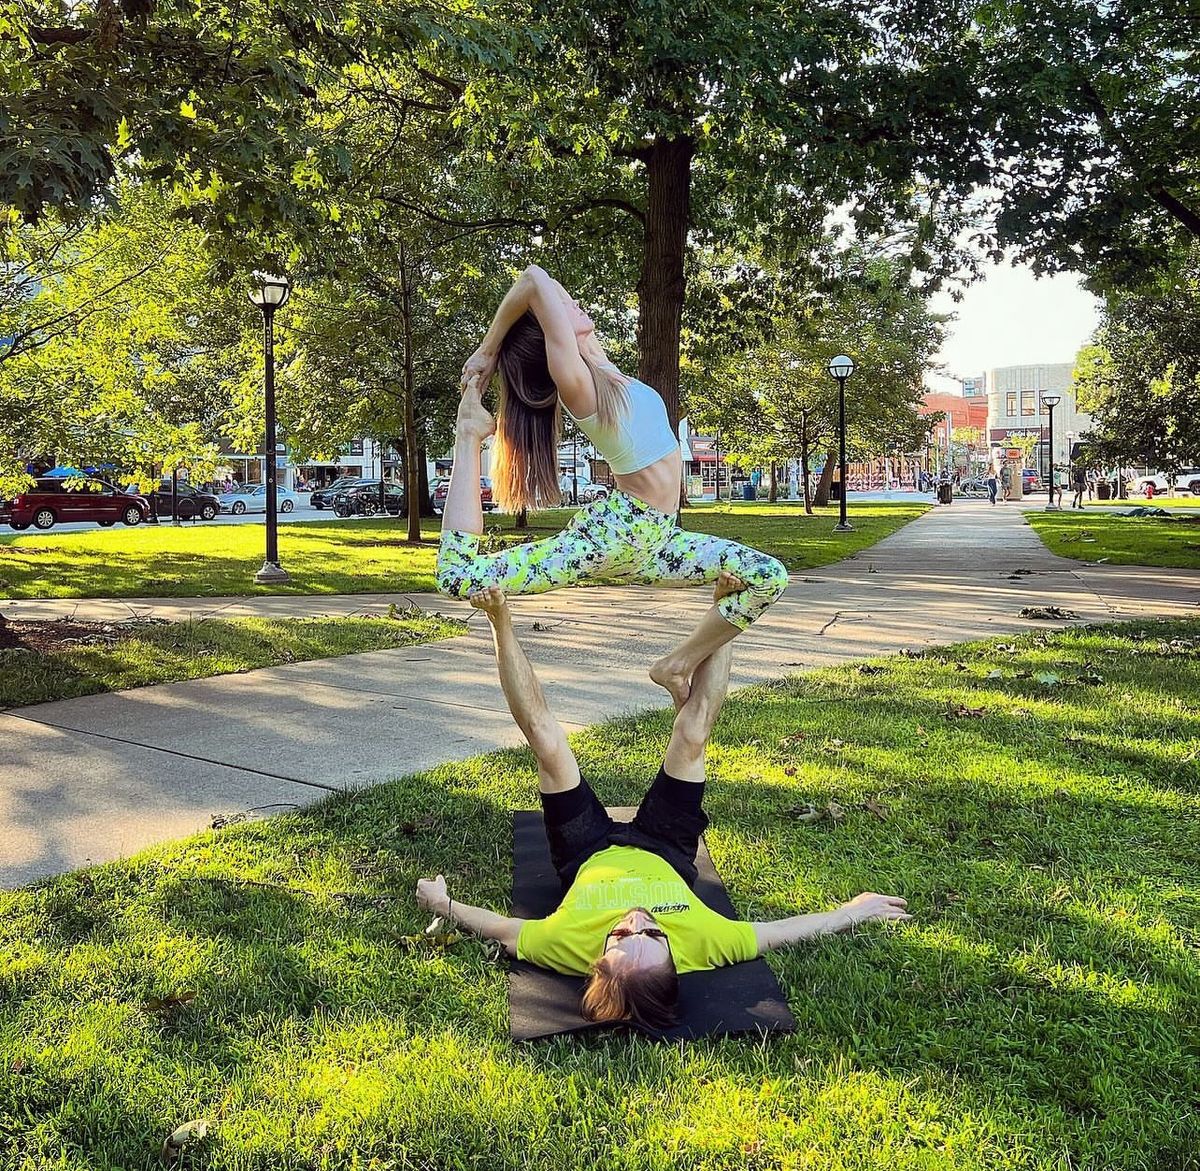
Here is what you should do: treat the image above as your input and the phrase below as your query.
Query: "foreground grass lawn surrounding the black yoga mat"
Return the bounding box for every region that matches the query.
[0,621,1200,1171]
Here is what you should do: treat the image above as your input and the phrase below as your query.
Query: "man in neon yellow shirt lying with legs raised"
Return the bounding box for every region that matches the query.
[416,574,911,1028]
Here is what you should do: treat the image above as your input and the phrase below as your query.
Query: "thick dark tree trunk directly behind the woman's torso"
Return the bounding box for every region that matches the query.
[637,137,696,428]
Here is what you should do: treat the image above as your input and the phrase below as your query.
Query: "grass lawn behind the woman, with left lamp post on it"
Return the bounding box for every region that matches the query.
[0,503,928,597]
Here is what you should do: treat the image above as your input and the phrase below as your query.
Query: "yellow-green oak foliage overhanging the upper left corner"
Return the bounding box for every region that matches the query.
[0,0,468,227]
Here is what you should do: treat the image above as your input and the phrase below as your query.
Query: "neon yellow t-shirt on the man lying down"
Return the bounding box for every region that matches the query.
[517,846,758,975]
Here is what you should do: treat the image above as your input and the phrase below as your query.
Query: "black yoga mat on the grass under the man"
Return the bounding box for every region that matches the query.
[509,807,796,1041]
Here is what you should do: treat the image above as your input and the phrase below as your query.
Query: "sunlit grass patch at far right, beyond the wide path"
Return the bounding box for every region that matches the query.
[1025,511,1200,569]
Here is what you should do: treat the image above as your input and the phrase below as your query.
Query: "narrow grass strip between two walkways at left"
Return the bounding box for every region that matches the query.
[0,611,464,708]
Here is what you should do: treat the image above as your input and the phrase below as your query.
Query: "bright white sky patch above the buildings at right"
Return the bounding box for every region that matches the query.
[925,265,1100,391]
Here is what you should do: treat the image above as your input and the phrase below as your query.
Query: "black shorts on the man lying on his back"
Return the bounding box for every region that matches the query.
[541,768,708,891]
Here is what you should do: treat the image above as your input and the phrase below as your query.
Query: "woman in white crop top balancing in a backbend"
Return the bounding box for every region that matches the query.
[438,266,787,705]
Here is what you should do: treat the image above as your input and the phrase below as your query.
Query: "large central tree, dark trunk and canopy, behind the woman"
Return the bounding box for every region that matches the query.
[432,0,986,424]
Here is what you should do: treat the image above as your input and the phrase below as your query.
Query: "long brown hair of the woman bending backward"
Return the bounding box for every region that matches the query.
[492,310,629,512]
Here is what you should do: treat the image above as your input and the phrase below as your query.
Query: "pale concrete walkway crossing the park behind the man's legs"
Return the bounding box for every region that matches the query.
[0,500,1200,885]
